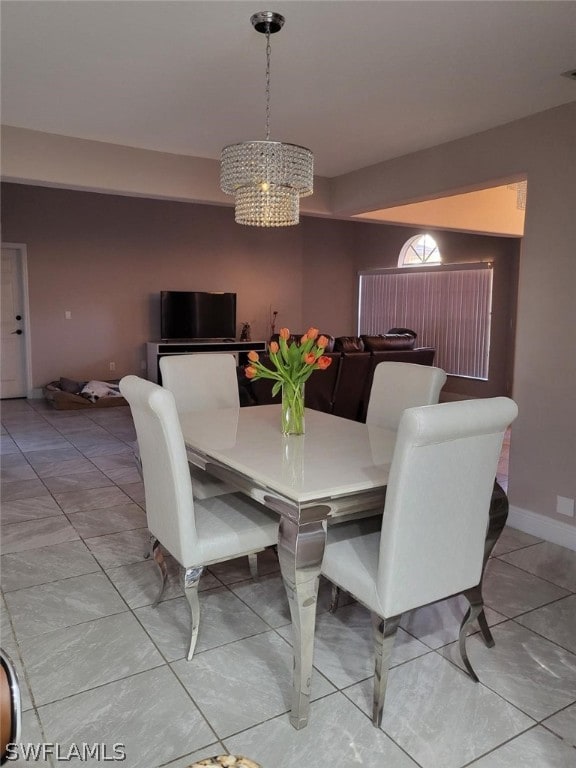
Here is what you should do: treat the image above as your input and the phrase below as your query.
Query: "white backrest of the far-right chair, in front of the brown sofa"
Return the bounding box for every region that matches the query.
[366,361,446,429]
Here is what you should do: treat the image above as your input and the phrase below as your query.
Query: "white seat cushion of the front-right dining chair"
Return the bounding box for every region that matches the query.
[322,515,382,613]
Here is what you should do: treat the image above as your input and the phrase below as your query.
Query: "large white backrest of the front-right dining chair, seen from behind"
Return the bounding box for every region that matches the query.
[376,397,518,616]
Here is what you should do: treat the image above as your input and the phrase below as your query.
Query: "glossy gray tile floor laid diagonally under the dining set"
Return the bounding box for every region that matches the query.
[1,400,576,768]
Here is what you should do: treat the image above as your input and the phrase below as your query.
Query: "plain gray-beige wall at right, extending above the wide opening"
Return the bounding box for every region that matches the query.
[332,102,576,528]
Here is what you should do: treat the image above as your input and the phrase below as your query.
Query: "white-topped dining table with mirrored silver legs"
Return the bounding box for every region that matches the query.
[180,405,396,729]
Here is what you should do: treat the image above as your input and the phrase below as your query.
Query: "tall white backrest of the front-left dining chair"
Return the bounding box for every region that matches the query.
[120,376,198,567]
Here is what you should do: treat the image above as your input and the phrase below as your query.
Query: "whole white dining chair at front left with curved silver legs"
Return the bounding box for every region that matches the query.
[120,376,278,660]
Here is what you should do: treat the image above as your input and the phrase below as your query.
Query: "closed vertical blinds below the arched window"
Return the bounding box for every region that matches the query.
[358,264,492,379]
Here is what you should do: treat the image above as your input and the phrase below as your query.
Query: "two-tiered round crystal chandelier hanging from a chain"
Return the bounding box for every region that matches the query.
[220,11,314,227]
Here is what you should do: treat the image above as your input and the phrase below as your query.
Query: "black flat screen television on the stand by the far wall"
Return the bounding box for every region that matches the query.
[160,291,236,340]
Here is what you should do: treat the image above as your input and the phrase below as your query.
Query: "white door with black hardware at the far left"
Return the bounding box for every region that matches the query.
[0,245,28,398]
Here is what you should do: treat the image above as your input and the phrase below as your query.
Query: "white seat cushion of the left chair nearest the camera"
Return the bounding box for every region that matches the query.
[194,493,279,567]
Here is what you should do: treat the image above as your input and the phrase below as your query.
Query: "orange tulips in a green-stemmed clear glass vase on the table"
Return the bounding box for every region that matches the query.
[246,328,332,435]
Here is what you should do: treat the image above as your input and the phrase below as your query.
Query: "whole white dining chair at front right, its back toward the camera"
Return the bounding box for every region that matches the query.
[322,397,518,726]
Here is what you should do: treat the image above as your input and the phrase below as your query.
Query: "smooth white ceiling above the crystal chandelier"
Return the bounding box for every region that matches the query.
[2,0,576,177]
